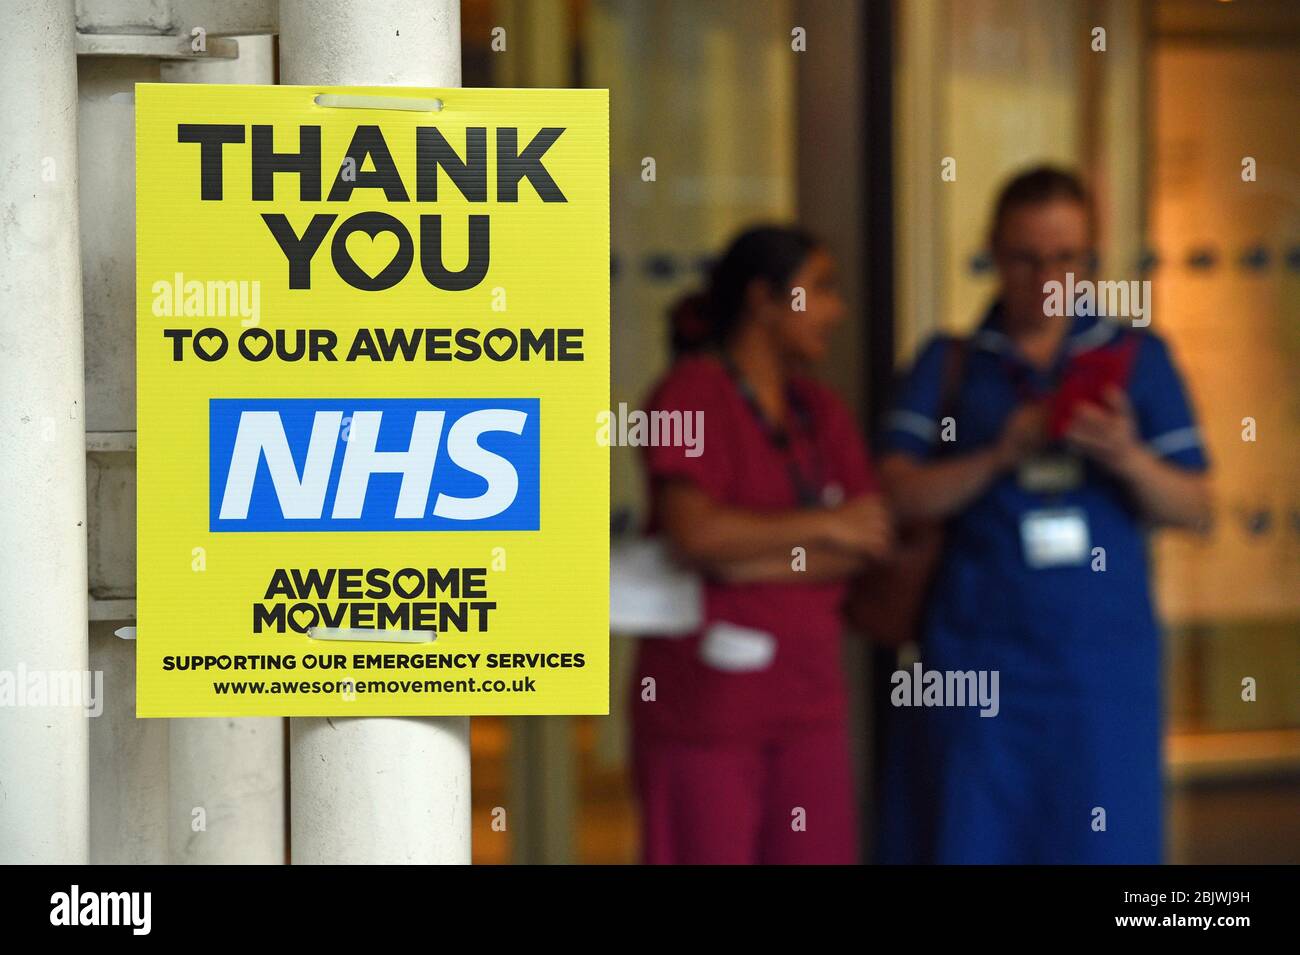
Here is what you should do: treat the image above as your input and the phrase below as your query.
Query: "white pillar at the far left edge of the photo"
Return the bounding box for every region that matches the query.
[0,0,90,864]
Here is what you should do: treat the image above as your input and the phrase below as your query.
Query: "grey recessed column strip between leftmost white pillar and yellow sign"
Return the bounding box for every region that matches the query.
[77,46,168,865]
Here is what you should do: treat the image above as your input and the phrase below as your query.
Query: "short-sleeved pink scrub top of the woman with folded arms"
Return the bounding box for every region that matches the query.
[632,356,878,739]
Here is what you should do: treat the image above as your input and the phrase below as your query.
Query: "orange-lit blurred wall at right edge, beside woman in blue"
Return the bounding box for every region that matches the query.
[1152,43,1300,631]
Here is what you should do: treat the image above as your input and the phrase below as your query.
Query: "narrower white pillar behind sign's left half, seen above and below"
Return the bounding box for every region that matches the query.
[161,36,287,865]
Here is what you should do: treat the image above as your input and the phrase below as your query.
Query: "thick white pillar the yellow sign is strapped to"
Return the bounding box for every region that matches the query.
[280,0,469,864]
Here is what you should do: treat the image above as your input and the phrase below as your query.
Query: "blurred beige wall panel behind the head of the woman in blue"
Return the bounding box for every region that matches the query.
[894,0,1144,361]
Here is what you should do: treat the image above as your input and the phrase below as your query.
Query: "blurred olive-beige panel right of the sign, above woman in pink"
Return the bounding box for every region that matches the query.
[584,0,798,522]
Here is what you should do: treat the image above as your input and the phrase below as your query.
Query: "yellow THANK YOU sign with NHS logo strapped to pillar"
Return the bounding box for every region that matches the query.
[135,84,610,716]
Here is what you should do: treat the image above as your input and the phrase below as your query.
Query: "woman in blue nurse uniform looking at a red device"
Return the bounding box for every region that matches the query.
[880,168,1210,863]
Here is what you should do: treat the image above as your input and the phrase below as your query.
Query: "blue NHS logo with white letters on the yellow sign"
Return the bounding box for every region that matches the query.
[208,398,541,531]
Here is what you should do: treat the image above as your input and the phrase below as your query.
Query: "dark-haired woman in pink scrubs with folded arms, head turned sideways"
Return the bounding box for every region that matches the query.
[632,227,891,864]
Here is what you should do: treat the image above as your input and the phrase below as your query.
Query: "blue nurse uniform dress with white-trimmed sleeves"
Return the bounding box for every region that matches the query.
[879,305,1206,863]
